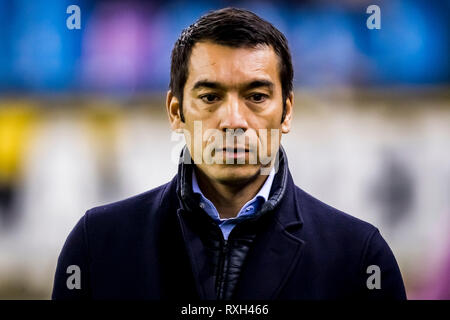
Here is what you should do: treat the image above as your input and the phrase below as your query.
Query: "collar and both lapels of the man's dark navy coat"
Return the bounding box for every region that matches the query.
[172,146,305,300]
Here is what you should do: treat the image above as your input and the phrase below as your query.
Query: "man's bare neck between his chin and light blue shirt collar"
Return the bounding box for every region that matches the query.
[195,168,268,219]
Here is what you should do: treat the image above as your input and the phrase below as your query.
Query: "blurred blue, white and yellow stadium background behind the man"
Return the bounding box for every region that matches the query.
[0,0,450,299]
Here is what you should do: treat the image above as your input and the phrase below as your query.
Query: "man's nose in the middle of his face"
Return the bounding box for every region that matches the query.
[219,96,248,132]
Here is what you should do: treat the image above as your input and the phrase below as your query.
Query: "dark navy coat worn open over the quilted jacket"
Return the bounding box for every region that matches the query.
[52,148,406,300]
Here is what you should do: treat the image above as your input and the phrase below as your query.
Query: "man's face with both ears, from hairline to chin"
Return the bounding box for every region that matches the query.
[167,42,293,184]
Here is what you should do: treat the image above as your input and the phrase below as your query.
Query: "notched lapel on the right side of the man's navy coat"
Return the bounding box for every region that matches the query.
[234,174,305,300]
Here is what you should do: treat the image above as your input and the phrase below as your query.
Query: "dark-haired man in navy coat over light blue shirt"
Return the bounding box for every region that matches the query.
[53,8,406,300]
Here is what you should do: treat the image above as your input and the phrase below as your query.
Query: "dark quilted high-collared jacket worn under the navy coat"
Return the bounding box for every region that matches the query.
[178,148,288,300]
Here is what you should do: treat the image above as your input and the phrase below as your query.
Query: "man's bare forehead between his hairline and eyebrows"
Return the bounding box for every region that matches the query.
[186,42,279,87]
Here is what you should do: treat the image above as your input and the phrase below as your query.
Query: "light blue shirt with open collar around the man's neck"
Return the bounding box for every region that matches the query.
[192,168,275,240]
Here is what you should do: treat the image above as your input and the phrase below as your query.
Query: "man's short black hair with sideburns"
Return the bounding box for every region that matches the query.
[169,8,294,122]
